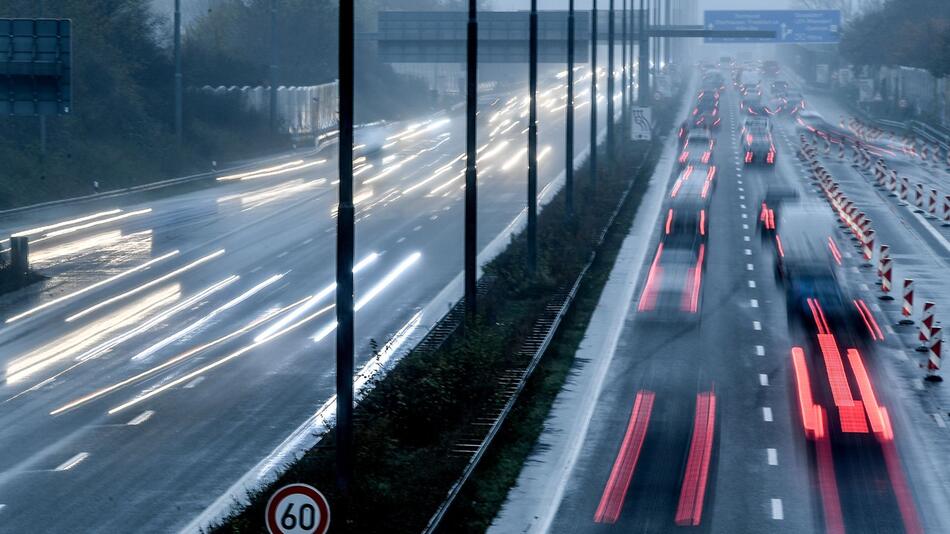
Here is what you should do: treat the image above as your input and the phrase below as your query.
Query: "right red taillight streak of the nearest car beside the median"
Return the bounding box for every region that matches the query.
[676,391,716,526]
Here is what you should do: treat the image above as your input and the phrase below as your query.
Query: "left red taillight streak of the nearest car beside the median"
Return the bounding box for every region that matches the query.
[594,391,655,523]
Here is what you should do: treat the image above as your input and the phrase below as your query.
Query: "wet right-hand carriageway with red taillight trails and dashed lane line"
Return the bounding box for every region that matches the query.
[490,63,950,534]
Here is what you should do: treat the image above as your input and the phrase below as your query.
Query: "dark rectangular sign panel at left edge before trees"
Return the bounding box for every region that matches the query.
[0,19,72,116]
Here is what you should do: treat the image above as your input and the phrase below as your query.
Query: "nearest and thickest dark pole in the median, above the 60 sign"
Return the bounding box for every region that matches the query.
[336,0,354,506]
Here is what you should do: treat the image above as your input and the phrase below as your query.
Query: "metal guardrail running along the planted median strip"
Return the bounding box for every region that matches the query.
[423,140,655,534]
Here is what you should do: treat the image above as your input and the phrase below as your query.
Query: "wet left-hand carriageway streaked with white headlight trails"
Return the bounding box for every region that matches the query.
[0,69,619,533]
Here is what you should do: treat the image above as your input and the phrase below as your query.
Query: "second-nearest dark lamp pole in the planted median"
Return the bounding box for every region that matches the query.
[465,0,478,321]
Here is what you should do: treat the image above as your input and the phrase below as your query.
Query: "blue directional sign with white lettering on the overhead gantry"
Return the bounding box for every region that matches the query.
[704,9,841,43]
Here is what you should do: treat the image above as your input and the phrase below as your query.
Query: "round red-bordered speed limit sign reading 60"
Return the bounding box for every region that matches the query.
[264,484,330,534]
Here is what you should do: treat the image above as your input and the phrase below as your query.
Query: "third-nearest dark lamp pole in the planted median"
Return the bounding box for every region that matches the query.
[528,0,538,273]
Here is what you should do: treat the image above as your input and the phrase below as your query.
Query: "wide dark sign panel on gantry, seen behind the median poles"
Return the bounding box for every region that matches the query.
[376,11,596,63]
